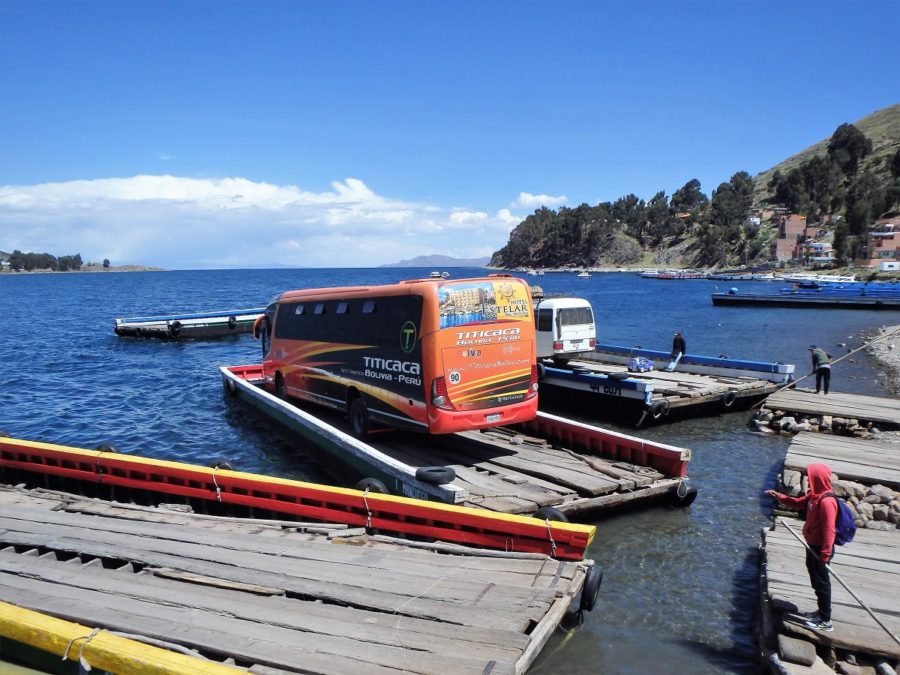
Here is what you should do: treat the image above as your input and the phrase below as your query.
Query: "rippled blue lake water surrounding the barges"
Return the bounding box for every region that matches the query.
[0,269,900,673]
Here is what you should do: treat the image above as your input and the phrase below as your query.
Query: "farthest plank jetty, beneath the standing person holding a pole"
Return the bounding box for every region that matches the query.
[762,388,900,429]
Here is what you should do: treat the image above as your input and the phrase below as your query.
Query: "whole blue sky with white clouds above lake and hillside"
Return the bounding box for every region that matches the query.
[0,0,900,269]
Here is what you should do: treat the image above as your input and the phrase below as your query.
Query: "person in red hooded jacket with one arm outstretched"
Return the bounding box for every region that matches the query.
[766,464,838,632]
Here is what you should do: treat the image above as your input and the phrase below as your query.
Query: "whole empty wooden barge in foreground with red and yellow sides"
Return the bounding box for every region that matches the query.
[0,438,602,675]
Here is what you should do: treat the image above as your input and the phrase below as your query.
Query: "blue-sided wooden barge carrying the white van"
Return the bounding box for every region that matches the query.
[541,345,794,427]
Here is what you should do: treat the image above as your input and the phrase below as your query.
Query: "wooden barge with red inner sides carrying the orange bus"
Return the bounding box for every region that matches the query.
[220,365,696,517]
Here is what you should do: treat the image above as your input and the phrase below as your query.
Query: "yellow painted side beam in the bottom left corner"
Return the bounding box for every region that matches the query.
[0,602,246,675]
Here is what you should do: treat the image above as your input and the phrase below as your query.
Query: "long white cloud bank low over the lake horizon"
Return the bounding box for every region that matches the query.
[0,175,526,269]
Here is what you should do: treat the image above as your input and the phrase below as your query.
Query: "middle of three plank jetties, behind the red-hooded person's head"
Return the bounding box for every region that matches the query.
[784,434,900,490]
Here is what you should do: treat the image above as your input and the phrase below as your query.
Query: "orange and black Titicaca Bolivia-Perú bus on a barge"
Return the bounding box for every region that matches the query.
[254,275,537,438]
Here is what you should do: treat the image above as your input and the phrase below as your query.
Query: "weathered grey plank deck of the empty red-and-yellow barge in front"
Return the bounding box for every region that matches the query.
[0,487,589,674]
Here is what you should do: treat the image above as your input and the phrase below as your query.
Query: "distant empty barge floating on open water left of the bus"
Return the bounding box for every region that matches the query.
[115,307,265,340]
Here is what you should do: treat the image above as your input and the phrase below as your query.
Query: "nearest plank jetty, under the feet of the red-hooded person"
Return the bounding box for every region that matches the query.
[761,518,900,661]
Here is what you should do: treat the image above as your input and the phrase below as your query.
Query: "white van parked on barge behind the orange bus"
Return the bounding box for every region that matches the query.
[534,298,597,363]
